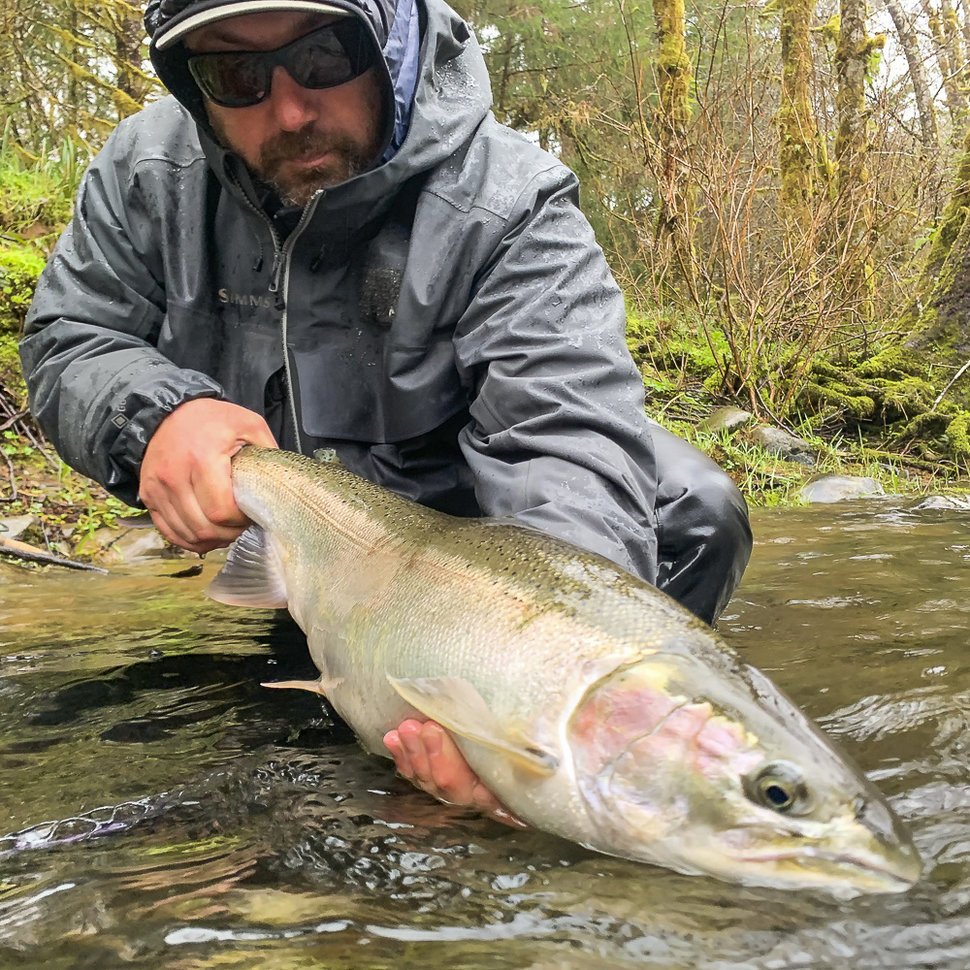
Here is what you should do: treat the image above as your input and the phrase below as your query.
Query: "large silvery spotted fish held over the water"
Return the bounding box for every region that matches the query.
[208,447,920,895]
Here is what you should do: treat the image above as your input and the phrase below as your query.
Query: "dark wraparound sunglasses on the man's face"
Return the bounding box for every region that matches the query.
[188,16,377,108]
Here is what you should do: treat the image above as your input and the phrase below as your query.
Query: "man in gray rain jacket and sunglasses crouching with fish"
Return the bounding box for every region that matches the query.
[21,0,751,811]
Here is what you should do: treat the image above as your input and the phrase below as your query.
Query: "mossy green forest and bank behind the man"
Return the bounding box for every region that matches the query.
[0,0,970,555]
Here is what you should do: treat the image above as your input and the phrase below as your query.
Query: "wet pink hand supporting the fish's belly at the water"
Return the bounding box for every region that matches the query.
[384,721,525,828]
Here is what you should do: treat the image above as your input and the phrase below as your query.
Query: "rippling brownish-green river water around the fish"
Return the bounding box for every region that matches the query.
[0,500,970,970]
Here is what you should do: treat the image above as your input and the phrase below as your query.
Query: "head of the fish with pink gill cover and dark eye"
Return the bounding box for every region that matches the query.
[568,655,921,897]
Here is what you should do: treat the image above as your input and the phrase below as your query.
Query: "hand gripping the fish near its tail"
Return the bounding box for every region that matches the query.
[138,398,276,553]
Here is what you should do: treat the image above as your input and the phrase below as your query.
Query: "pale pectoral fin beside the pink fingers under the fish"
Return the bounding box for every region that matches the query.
[387,676,559,776]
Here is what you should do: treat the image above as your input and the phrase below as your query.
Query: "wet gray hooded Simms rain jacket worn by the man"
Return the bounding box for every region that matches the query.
[21,0,657,582]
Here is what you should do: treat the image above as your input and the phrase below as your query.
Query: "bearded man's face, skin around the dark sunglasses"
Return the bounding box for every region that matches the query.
[186,11,383,206]
